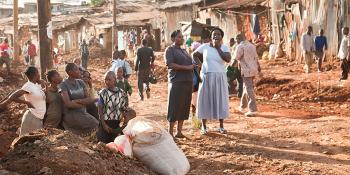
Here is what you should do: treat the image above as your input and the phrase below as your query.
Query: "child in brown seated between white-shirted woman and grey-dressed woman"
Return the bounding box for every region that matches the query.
[44,70,63,129]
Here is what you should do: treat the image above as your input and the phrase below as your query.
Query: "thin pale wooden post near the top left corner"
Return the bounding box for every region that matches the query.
[13,0,19,61]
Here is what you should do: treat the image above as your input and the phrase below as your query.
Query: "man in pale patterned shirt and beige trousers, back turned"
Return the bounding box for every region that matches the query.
[235,34,261,117]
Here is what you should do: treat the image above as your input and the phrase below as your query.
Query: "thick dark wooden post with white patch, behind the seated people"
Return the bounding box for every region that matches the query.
[37,0,53,78]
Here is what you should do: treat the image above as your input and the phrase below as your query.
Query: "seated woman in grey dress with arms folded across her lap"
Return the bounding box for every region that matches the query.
[59,63,98,136]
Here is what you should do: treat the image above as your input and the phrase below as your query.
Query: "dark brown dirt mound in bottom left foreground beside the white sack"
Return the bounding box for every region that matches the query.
[0,129,154,175]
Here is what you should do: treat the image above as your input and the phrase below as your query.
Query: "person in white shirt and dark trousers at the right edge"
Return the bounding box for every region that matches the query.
[338,27,350,80]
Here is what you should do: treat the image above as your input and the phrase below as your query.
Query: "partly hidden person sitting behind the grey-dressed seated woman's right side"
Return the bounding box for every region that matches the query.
[81,70,98,120]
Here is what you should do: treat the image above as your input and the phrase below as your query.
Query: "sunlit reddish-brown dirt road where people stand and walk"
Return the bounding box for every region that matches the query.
[0,54,350,175]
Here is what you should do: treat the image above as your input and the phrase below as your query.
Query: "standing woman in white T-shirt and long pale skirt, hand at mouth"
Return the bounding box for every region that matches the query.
[193,28,231,134]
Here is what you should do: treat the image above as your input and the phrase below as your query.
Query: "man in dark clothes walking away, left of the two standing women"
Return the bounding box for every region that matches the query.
[135,39,155,101]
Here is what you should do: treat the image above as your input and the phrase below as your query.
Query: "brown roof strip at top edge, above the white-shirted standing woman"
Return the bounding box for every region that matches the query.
[206,0,267,9]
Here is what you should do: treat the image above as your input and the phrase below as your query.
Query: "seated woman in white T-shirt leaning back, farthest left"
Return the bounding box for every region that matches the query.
[0,66,46,136]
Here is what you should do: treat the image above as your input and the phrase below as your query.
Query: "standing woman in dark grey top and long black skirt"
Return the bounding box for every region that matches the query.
[164,30,196,138]
